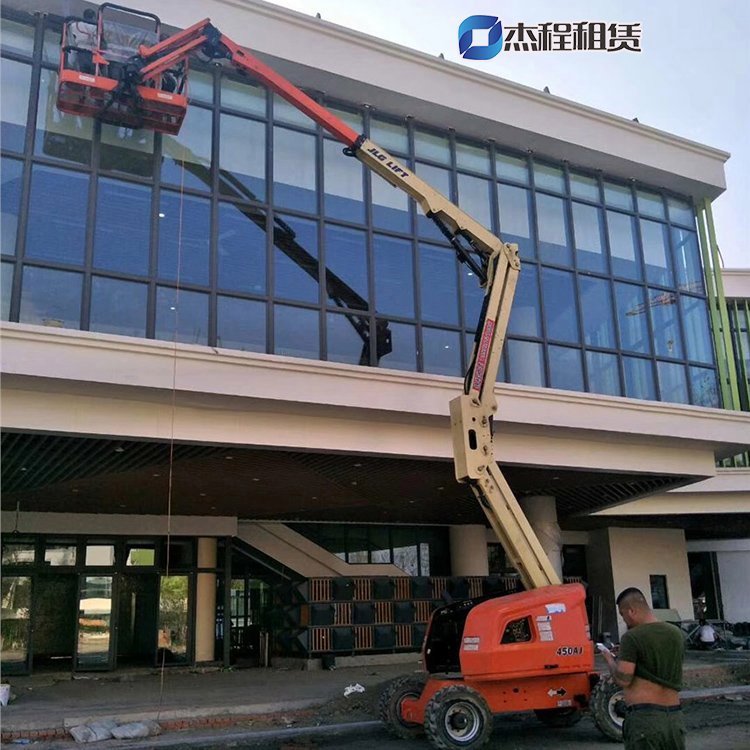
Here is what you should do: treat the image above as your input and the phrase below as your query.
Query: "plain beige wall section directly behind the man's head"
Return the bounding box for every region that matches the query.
[608,528,693,633]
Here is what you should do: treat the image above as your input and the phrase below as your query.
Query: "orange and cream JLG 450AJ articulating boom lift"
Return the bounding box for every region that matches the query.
[58,3,622,748]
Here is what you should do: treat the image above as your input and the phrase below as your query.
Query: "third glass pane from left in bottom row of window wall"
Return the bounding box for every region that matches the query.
[89,276,148,337]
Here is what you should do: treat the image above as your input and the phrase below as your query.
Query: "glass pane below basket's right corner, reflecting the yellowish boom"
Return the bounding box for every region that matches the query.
[161,107,213,190]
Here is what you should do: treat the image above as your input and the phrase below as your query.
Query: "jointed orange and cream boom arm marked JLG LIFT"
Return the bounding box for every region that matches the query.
[138,19,560,589]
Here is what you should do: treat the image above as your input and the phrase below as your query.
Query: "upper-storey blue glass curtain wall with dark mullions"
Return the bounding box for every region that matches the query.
[1,10,719,406]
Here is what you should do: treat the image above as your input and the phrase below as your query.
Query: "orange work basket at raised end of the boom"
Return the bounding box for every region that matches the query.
[57,3,188,134]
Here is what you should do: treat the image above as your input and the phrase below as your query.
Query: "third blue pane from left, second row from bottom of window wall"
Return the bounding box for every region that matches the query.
[94,177,151,276]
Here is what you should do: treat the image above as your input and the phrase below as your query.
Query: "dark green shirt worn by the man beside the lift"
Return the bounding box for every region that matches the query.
[618,622,685,690]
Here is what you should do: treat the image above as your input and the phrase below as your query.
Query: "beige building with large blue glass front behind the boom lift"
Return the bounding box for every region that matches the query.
[2,0,750,670]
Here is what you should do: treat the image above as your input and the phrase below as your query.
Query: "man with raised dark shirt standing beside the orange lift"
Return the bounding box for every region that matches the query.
[599,588,685,750]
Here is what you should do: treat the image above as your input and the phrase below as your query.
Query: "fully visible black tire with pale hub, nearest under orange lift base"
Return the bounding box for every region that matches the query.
[424,685,492,750]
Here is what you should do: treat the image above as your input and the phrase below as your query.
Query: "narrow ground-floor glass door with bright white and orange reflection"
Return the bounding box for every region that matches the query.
[75,575,114,671]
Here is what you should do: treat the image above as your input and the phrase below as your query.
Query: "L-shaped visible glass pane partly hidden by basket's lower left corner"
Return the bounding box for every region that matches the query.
[34,68,94,164]
